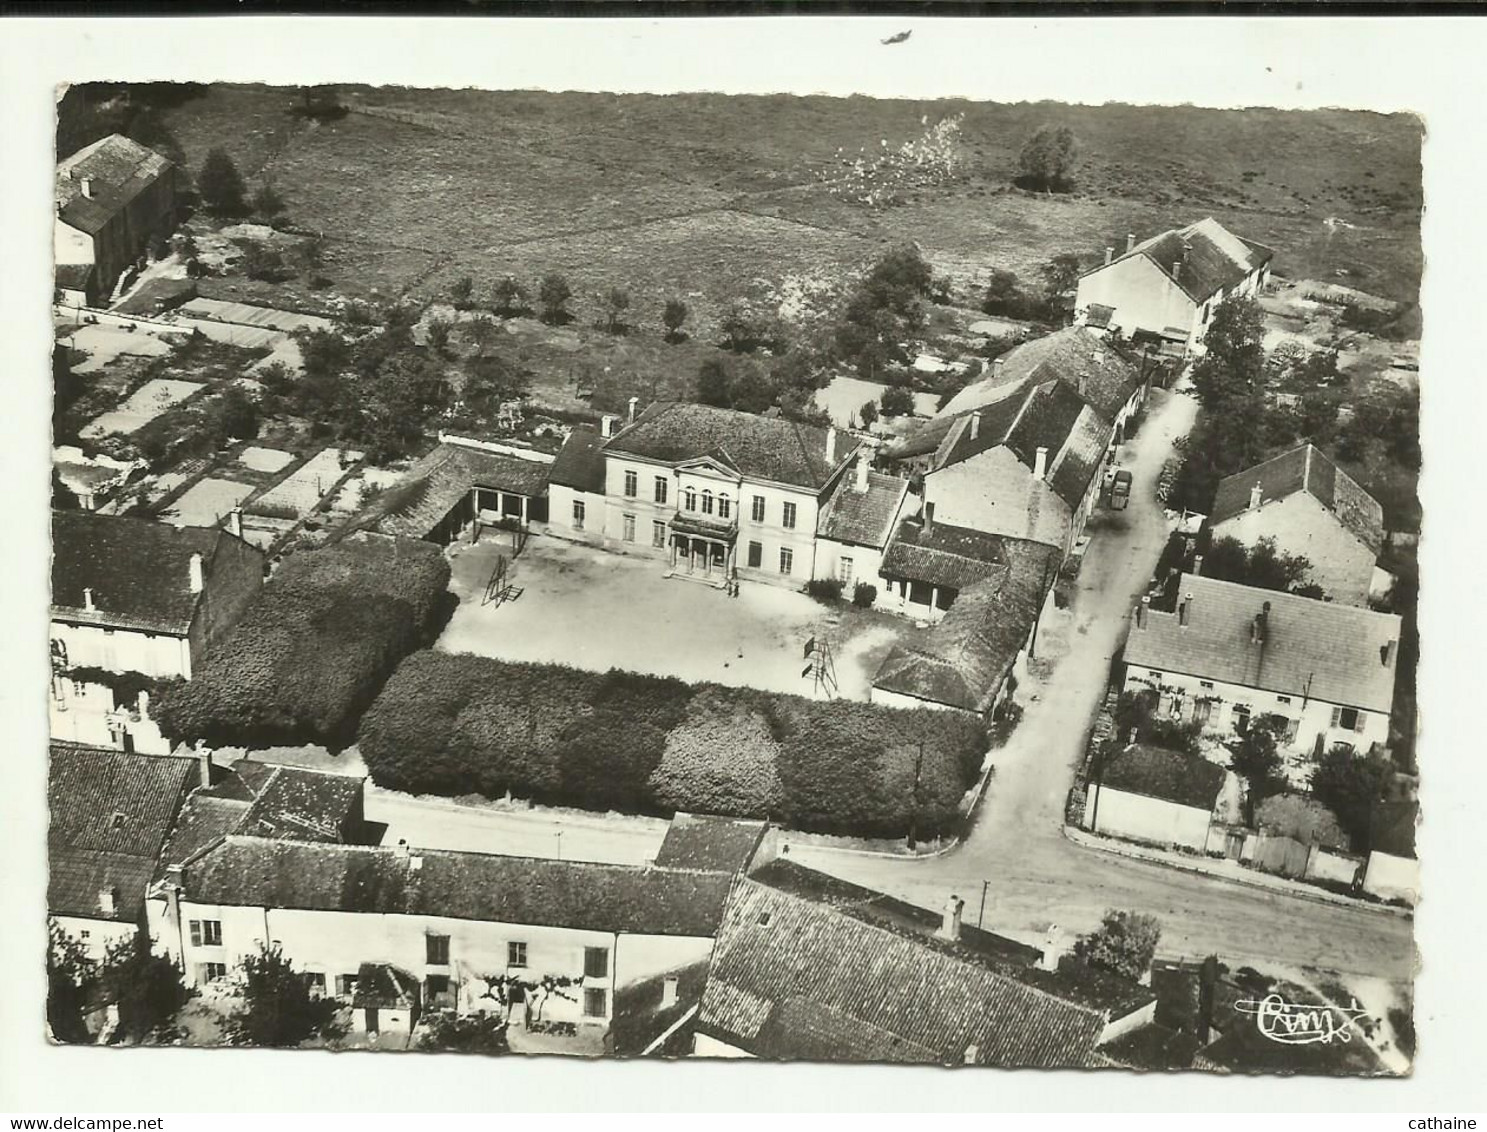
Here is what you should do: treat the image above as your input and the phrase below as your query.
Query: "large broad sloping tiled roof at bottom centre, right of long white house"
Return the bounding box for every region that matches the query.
[697,863,1149,1067]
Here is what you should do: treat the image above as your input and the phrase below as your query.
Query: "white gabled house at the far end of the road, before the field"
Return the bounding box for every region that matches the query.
[1074,217,1274,353]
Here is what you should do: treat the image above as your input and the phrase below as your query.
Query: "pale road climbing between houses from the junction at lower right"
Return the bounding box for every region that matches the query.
[791,379,1414,979]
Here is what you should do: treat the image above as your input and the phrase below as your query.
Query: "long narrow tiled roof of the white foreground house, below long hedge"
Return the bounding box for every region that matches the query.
[181,834,733,937]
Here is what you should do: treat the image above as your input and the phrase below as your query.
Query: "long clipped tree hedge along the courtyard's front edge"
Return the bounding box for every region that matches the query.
[358,652,987,837]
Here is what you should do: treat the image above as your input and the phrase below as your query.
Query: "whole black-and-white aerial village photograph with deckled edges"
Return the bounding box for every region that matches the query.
[43,77,1423,1077]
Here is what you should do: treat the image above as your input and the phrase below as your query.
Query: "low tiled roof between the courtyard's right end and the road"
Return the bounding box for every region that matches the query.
[873,538,1059,711]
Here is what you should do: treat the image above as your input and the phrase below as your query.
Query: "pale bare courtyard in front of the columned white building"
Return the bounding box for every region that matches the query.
[439,533,925,701]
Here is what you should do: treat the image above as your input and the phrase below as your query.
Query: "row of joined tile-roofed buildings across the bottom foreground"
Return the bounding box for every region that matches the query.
[48,744,1155,1067]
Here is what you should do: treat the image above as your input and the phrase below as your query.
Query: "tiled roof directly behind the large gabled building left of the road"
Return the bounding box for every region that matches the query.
[940,331,1141,424]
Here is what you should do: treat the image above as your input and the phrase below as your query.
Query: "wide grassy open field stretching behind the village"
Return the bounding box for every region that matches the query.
[142,86,1422,324]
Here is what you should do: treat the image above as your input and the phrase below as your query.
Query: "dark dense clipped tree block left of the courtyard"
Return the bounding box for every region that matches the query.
[155,536,449,750]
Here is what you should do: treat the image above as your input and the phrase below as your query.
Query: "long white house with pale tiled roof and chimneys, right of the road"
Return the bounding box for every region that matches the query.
[1124,574,1399,754]
